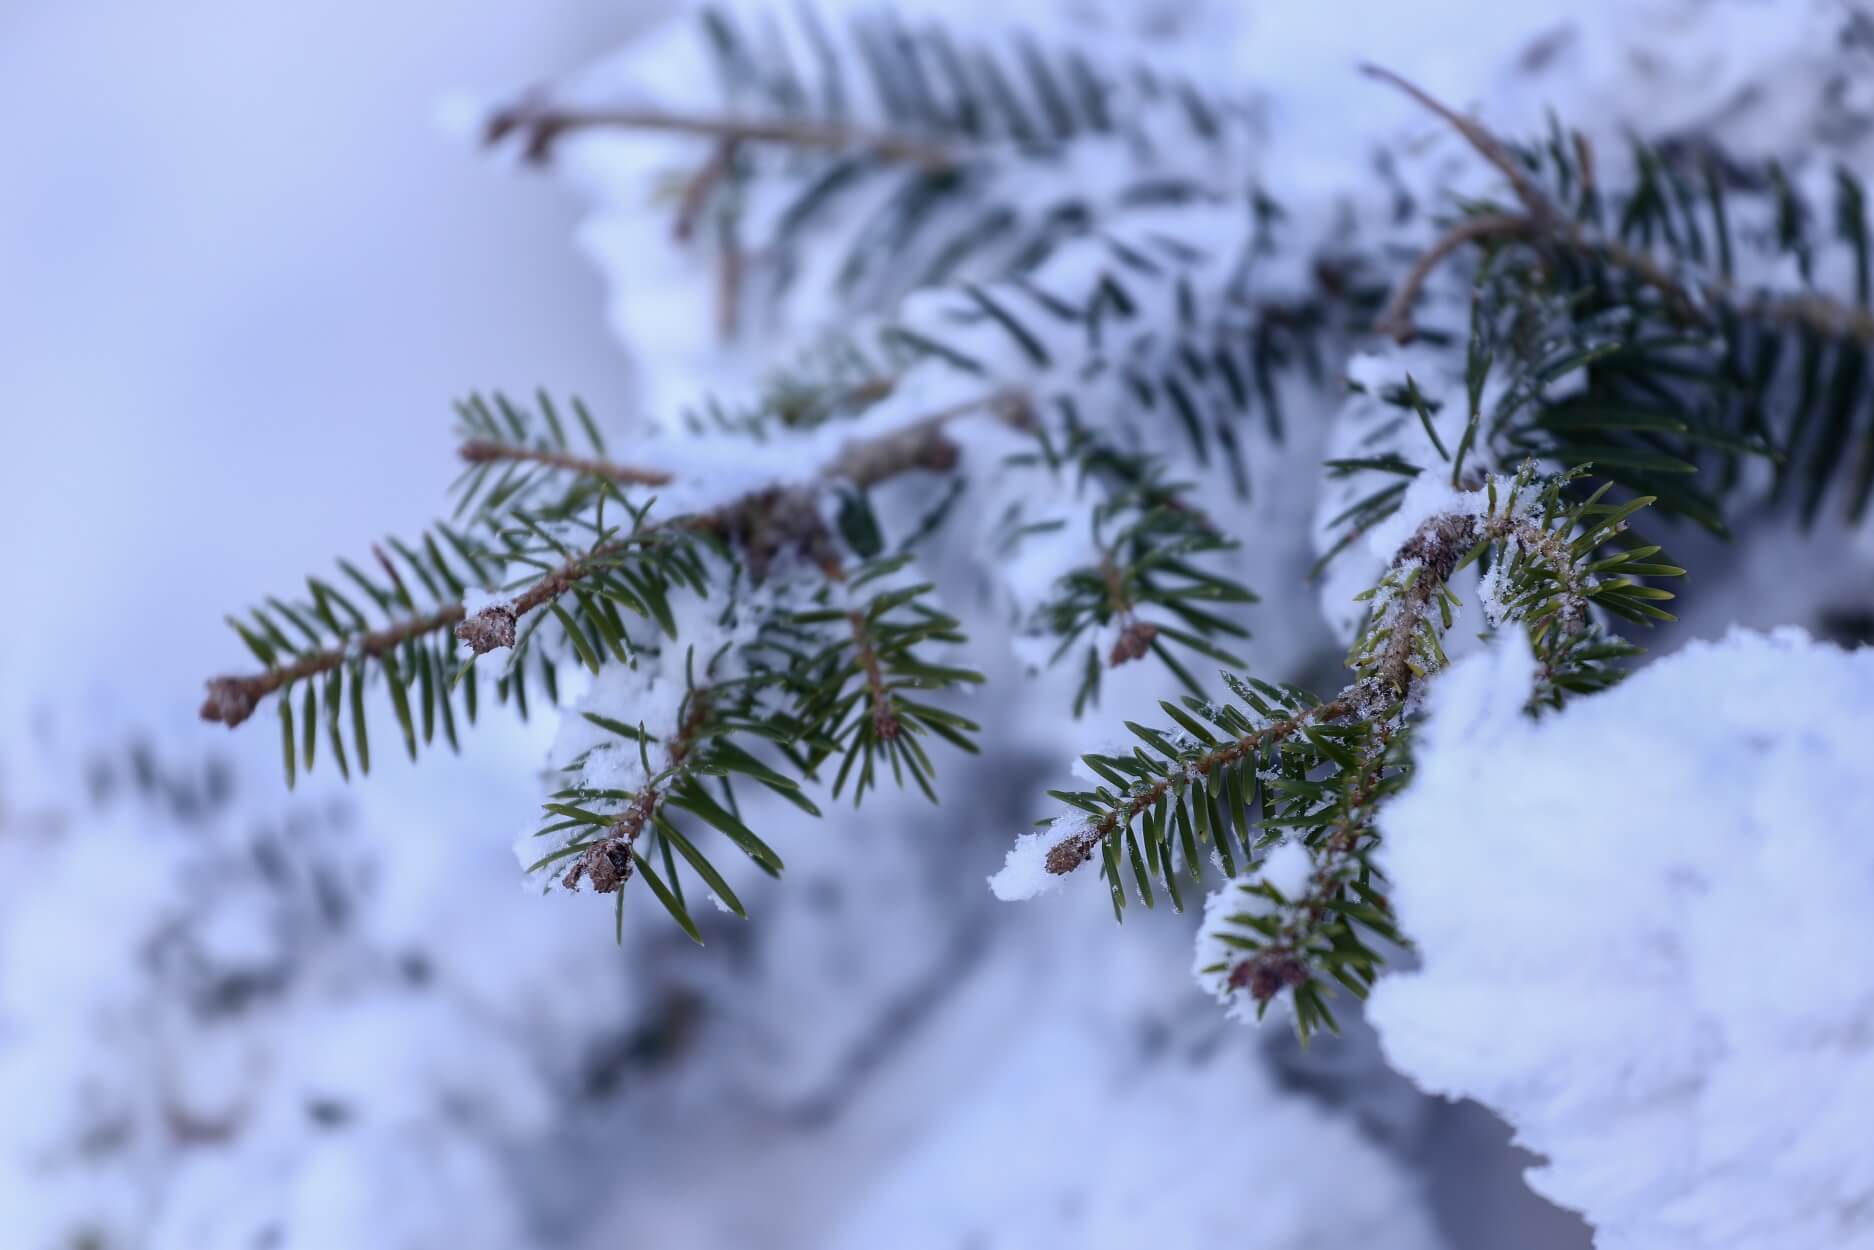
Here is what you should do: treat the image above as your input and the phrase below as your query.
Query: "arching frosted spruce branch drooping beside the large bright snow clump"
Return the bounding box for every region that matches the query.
[1042,465,1681,1038]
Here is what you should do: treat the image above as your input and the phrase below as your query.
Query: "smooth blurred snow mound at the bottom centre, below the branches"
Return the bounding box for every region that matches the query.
[830,907,1445,1250]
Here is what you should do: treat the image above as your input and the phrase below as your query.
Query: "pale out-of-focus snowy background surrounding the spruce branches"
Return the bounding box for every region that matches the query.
[0,0,1868,1250]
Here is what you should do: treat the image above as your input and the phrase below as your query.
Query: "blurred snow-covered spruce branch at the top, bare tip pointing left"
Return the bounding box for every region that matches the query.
[485,9,1256,342]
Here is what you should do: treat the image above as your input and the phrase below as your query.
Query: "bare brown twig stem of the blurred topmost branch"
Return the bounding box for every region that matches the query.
[485,99,958,171]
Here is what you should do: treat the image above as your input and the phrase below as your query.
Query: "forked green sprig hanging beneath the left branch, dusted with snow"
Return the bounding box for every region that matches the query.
[513,558,982,941]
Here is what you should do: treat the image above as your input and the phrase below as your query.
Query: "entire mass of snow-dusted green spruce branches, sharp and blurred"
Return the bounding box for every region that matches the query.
[202,9,1874,1038]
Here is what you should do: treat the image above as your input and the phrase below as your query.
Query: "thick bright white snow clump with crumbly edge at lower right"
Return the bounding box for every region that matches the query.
[1368,630,1874,1250]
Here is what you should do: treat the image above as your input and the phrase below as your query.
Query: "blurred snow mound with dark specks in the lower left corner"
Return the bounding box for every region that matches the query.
[0,718,641,1250]
